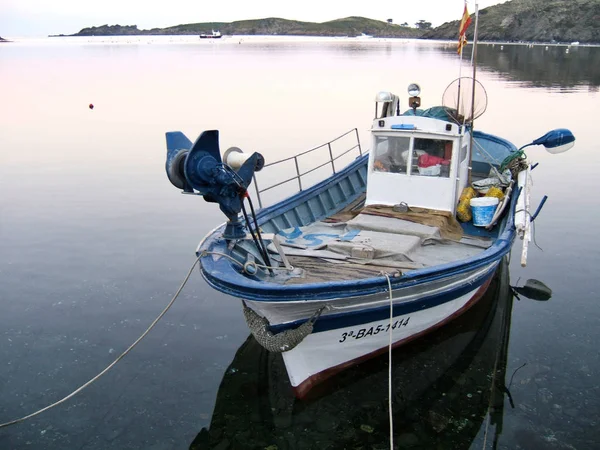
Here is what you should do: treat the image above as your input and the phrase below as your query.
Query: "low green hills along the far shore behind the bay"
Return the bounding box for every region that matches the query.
[59,0,600,43]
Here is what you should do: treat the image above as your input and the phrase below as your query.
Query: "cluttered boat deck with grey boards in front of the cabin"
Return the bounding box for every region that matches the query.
[269,197,496,284]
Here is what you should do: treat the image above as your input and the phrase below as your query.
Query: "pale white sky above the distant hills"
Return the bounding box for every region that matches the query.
[0,0,505,37]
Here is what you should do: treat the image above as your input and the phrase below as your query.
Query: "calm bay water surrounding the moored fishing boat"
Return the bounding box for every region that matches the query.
[0,37,600,449]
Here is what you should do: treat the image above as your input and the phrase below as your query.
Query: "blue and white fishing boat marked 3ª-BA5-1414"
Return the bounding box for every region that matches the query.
[166,78,575,397]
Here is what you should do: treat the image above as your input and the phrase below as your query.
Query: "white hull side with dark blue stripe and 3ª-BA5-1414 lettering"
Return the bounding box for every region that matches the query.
[238,260,499,397]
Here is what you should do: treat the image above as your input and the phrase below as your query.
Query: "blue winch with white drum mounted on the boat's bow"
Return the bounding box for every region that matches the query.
[165,130,265,239]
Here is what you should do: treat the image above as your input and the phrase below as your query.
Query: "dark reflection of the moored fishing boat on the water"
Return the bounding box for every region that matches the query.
[190,261,513,450]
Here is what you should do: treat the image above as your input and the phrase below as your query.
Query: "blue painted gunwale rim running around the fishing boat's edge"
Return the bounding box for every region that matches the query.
[199,131,517,302]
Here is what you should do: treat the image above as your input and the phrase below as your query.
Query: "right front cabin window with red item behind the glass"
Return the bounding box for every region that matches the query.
[411,138,452,178]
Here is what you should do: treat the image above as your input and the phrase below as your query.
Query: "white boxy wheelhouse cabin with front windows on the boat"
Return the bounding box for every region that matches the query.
[366,111,470,214]
